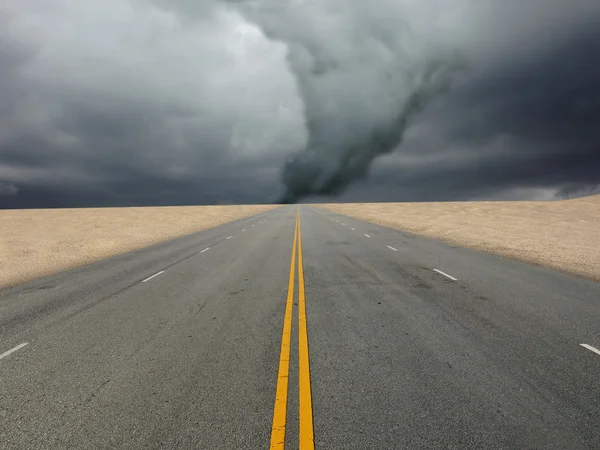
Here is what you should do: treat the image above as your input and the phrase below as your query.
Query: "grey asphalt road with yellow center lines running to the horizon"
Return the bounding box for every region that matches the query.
[0,206,600,449]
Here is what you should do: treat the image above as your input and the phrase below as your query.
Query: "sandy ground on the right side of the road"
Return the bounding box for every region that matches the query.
[319,195,600,281]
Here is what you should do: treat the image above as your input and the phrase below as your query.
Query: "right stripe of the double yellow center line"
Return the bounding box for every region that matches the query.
[297,212,315,450]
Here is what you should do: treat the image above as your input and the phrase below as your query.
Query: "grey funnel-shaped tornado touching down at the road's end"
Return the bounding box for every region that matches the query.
[230,0,465,204]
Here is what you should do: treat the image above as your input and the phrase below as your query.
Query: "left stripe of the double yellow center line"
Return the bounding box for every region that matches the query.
[270,216,299,450]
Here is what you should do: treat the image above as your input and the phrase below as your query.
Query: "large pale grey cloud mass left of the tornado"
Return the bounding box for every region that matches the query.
[0,0,304,207]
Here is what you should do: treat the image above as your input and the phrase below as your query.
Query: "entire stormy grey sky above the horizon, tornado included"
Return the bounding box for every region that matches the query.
[0,0,600,209]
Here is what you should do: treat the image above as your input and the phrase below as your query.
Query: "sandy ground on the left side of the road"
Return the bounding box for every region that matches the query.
[0,205,276,287]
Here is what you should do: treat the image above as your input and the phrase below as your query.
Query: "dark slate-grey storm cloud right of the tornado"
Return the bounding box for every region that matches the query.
[346,21,600,200]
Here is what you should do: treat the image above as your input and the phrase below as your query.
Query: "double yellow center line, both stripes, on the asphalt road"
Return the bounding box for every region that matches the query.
[271,209,315,450]
